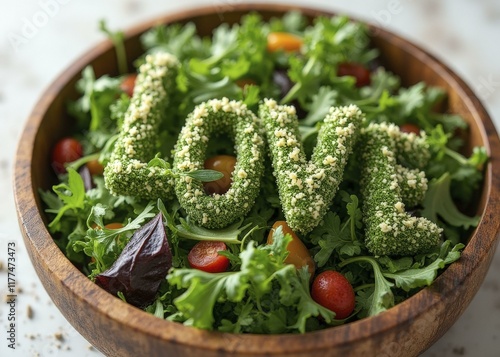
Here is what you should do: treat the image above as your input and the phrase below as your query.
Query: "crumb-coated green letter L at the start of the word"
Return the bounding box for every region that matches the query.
[104,52,179,199]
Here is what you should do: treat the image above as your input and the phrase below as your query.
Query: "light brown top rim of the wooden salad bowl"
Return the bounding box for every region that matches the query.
[14,4,500,354]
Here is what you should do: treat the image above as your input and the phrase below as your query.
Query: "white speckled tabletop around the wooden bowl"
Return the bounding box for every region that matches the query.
[0,0,500,357]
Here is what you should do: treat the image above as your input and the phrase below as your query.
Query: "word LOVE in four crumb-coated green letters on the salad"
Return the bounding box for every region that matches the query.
[104,53,440,254]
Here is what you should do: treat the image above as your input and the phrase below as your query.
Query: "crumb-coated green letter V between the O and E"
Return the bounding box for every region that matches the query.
[259,99,364,234]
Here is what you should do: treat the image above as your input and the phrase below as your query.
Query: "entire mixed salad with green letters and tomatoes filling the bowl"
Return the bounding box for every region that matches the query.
[40,12,488,334]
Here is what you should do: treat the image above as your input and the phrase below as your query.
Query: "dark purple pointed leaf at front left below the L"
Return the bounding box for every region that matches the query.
[95,213,172,307]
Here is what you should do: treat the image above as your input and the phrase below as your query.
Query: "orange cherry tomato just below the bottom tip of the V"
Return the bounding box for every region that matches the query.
[267,221,315,276]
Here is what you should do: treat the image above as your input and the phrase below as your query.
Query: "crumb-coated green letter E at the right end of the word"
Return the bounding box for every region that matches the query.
[358,123,442,256]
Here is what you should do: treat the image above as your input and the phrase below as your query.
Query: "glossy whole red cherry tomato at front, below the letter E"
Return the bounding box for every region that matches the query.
[311,270,356,320]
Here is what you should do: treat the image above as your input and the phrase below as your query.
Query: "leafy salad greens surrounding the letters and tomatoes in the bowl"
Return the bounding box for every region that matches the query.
[40,12,488,333]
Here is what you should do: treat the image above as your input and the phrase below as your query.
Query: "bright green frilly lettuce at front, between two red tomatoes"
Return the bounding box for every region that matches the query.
[167,227,335,333]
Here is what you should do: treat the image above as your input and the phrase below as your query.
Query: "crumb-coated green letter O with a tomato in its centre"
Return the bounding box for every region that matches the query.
[173,98,264,229]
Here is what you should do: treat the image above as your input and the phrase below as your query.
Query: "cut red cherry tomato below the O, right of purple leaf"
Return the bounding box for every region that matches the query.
[188,241,229,273]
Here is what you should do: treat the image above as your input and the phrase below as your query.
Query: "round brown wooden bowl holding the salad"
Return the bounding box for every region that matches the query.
[14,4,500,357]
